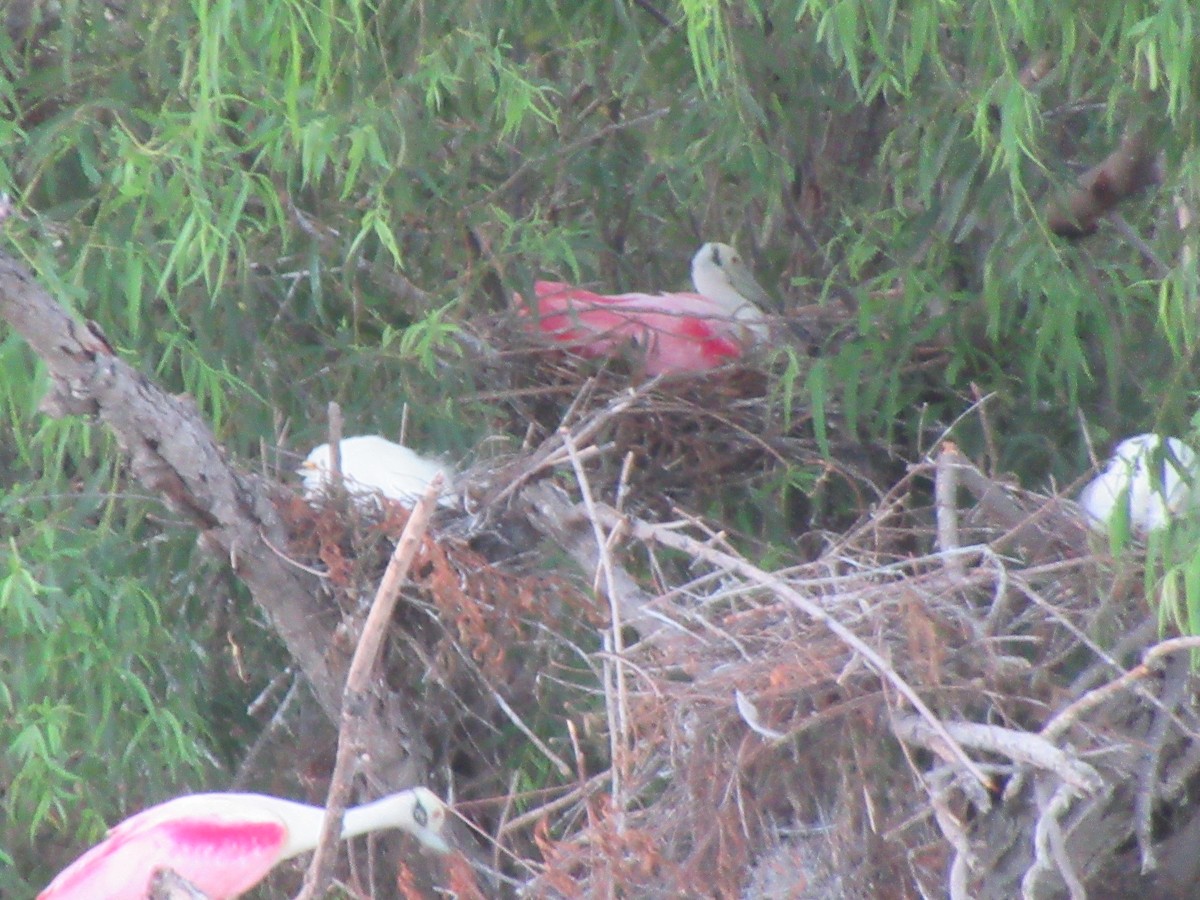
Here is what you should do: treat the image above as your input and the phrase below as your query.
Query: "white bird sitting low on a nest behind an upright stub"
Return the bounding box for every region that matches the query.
[299,434,458,508]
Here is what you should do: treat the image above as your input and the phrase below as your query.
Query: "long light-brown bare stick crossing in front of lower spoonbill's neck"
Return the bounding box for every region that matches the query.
[296,475,442,900]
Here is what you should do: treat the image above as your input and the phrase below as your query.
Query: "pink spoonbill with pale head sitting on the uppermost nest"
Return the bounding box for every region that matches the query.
[517,244,770,376]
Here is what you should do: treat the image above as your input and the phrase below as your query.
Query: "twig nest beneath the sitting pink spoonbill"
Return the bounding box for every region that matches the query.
[474,307,907,517]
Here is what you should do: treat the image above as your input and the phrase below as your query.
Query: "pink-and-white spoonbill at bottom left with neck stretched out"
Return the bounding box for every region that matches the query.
[37,787,450,900]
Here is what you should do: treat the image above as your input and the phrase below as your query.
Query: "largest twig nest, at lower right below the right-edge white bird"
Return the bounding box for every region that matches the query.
[501,450,1200,898]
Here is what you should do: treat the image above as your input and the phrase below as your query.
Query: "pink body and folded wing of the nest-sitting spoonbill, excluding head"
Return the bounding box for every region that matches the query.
[534,281,743,376]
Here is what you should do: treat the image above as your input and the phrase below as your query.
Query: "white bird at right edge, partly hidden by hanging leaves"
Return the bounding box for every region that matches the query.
[1079,434,1200,534]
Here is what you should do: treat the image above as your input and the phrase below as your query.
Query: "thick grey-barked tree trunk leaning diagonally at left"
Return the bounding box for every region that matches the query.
[0,253,424,787]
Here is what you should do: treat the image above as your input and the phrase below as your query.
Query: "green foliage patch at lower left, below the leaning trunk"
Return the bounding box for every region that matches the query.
[0,458,218,895]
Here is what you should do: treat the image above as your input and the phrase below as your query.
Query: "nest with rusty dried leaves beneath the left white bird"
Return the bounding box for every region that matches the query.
[276,492,604,816]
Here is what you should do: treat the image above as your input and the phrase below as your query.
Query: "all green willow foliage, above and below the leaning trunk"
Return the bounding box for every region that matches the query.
[0,0,1200,888]
